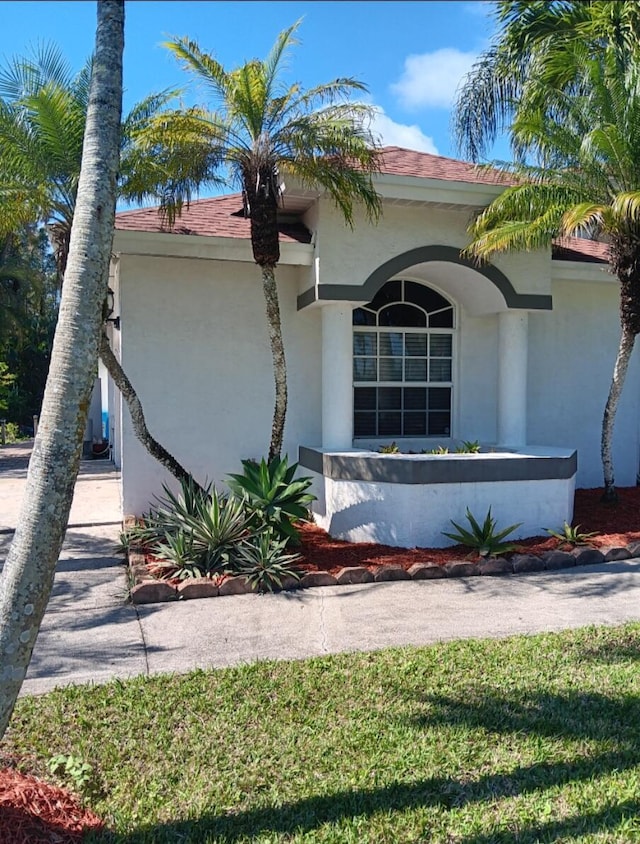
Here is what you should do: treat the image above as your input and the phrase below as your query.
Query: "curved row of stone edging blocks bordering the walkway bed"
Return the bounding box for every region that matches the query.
[129,542,640,604]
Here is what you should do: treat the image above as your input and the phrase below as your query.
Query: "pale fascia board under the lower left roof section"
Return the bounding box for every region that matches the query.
[113,229,314,267]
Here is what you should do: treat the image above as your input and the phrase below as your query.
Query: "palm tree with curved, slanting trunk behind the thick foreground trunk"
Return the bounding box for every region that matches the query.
[0,46,198,479]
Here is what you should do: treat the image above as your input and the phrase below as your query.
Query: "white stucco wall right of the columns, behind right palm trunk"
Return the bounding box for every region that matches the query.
[528,280,640,487]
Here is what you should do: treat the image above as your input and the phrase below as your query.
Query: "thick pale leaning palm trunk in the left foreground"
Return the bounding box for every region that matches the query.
[0,0,124,738]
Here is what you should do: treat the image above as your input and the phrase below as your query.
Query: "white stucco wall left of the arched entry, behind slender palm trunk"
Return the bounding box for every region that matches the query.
[119,255,321,513]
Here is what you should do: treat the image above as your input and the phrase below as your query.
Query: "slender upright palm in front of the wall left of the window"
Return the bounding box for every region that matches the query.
[144,24,381,459]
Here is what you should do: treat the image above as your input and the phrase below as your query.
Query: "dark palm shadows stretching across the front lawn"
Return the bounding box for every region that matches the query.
[94,692,640,844]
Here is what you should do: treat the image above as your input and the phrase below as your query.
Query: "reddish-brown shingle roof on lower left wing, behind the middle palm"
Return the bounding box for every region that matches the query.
[116,193,311,243]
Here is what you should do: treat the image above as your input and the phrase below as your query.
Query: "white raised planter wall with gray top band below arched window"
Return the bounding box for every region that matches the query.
[299,446,577,548]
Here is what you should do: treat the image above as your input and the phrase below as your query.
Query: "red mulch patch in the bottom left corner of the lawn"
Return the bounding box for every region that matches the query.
[0,768,104,844]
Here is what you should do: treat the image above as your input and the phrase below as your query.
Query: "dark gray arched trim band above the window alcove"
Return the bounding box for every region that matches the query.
[298,245,553,311]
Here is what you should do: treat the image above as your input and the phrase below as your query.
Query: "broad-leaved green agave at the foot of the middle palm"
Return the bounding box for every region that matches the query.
[227,456,315,544]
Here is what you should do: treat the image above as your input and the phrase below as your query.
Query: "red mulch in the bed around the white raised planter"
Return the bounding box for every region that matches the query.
[297,487,640,574]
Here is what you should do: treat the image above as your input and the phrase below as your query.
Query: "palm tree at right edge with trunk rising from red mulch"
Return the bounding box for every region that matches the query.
[460,41,640,501]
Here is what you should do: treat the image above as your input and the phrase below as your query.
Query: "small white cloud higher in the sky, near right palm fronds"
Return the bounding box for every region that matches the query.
[391,47,477,109]
